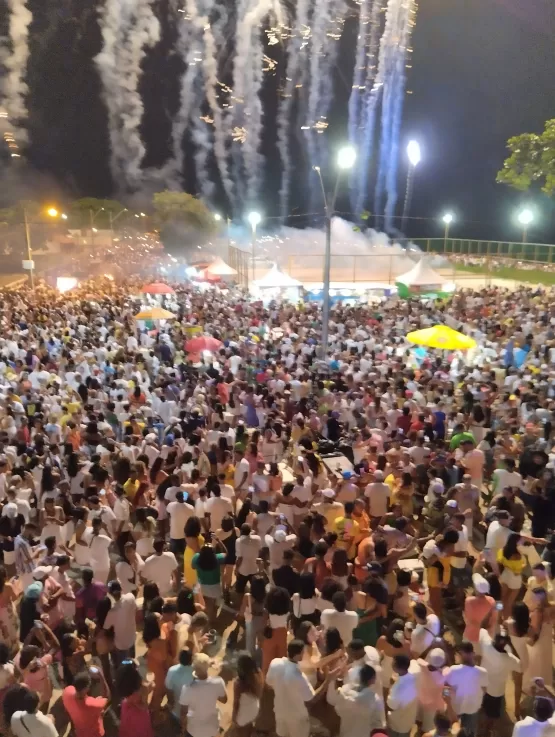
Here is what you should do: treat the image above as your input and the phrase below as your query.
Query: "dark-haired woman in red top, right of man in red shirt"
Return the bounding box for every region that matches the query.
[116,662,154,737]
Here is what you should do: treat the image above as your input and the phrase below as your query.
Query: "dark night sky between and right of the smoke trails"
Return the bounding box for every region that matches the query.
[4,0,555,242]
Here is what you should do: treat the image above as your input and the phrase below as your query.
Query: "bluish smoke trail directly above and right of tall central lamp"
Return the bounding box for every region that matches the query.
[350,0,384,215]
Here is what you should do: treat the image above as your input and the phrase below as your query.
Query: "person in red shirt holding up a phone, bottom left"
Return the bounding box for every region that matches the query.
[62,668,110,737]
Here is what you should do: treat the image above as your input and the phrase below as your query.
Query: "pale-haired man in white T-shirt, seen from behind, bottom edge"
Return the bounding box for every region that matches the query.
[179,653,227,737]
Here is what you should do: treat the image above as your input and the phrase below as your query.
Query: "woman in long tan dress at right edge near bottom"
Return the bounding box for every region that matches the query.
[515,588,555,693]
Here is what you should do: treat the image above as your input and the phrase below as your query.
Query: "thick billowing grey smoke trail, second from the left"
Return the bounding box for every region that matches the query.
[95,0,160,189]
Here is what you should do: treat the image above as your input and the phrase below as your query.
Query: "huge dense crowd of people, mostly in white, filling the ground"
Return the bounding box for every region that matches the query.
[0,279,555,737]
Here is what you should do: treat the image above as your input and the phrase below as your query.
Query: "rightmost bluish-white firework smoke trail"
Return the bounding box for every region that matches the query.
[374,0,414,228]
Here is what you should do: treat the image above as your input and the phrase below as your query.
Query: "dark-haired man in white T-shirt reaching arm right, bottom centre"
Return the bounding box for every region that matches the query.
[266,640,338,737]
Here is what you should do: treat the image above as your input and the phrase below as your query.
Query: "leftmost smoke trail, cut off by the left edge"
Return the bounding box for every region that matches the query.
[1,0,33,141]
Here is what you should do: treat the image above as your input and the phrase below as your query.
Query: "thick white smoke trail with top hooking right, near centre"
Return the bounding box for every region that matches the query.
[232,0,283,210]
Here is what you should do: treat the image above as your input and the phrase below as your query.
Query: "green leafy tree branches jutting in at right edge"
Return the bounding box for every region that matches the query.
[497,119,555,196]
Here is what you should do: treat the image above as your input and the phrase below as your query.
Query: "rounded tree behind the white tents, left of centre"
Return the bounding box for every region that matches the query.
[152,190,216,256]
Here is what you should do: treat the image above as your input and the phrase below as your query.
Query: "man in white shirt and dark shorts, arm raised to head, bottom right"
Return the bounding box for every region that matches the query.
[480,629,522,734]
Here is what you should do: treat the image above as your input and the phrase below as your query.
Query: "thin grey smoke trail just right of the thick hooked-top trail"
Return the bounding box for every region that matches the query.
[277,0,312,219]
